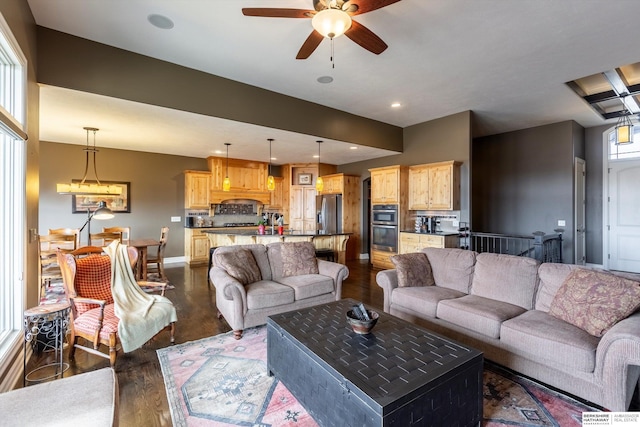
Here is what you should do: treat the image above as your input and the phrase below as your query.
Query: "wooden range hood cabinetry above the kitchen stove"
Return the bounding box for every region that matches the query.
[207,157,271,205]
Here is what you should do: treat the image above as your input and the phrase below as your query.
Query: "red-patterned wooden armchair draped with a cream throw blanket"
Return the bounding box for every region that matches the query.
[57,246,175,368]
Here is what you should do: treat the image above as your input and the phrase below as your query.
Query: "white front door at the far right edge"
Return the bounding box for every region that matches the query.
[608,160,640,273]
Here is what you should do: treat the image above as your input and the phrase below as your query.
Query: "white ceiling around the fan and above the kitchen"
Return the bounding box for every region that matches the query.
[28,0,640,164]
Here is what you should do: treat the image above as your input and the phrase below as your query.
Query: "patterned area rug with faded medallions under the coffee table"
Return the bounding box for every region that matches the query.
[157,326,597,427]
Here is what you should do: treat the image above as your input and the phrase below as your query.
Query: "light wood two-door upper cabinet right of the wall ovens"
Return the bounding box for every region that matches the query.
[410,161,461,211]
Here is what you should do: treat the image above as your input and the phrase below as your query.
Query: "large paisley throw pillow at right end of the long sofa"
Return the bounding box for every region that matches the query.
[549,268,640,337]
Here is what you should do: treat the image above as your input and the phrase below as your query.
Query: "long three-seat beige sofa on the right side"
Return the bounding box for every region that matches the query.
[377,248,640,411]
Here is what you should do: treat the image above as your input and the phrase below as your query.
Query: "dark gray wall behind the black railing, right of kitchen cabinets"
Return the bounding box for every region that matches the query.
[471,121,584,263]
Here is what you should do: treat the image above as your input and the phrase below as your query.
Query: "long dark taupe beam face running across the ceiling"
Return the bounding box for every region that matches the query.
[38,27,402,151]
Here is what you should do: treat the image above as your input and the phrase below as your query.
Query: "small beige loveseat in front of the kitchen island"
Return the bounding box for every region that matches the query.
[209,242,349,339]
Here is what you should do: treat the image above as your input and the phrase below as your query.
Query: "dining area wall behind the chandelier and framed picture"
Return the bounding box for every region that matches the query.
[39,144,207,257]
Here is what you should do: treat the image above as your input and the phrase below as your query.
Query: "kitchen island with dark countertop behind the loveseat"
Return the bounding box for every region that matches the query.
[202,227,352,264]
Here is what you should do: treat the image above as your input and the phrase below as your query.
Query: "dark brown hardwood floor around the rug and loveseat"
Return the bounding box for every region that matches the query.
[27,260,383,427]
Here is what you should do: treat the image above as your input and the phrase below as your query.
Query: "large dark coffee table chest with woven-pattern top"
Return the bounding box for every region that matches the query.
[267,299,483,427]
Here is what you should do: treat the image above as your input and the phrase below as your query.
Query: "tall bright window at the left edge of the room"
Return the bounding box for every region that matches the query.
[0,15,26,361]
